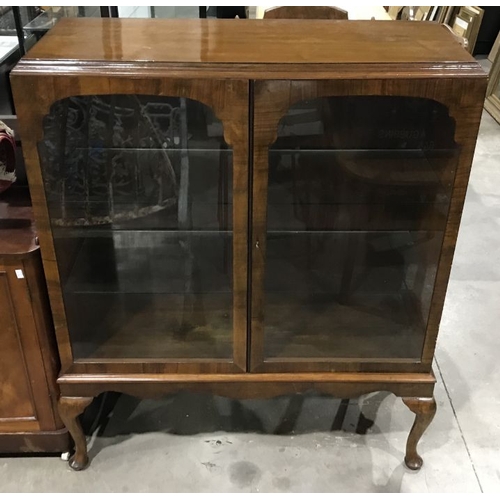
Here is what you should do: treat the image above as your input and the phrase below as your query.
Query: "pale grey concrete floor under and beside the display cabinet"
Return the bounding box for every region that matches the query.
[0,99,500,492]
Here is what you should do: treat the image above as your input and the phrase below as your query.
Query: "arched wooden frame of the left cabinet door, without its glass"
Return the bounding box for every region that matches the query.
[11,75,249,375]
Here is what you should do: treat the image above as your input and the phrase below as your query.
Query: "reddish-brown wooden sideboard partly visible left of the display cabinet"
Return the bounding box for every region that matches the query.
[0,186,70,453]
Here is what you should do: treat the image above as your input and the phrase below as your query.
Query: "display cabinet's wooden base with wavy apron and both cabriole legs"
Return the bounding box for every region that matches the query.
[58,373,436,471]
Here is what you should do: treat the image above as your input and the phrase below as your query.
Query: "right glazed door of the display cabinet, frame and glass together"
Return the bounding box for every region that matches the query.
[250,80,482,371]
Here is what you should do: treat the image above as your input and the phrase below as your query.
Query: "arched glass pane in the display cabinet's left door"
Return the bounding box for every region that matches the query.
[39,95,232,359]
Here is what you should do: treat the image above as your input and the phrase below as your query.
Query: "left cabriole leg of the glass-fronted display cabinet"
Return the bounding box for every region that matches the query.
[58,397,94,470]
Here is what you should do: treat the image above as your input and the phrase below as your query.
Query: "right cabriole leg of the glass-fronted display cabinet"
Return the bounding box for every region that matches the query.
[403,398,436,470]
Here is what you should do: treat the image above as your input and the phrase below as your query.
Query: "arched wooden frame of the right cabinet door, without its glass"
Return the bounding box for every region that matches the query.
[249,77,486,372]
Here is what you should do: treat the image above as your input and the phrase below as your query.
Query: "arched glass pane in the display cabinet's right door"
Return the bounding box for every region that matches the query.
[264,96,457,359]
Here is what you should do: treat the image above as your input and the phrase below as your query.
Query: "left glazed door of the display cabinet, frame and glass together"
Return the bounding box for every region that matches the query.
[16,77,248,373]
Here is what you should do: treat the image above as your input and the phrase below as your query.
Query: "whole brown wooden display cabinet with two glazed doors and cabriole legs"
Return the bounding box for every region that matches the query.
[12,19,486,469]
